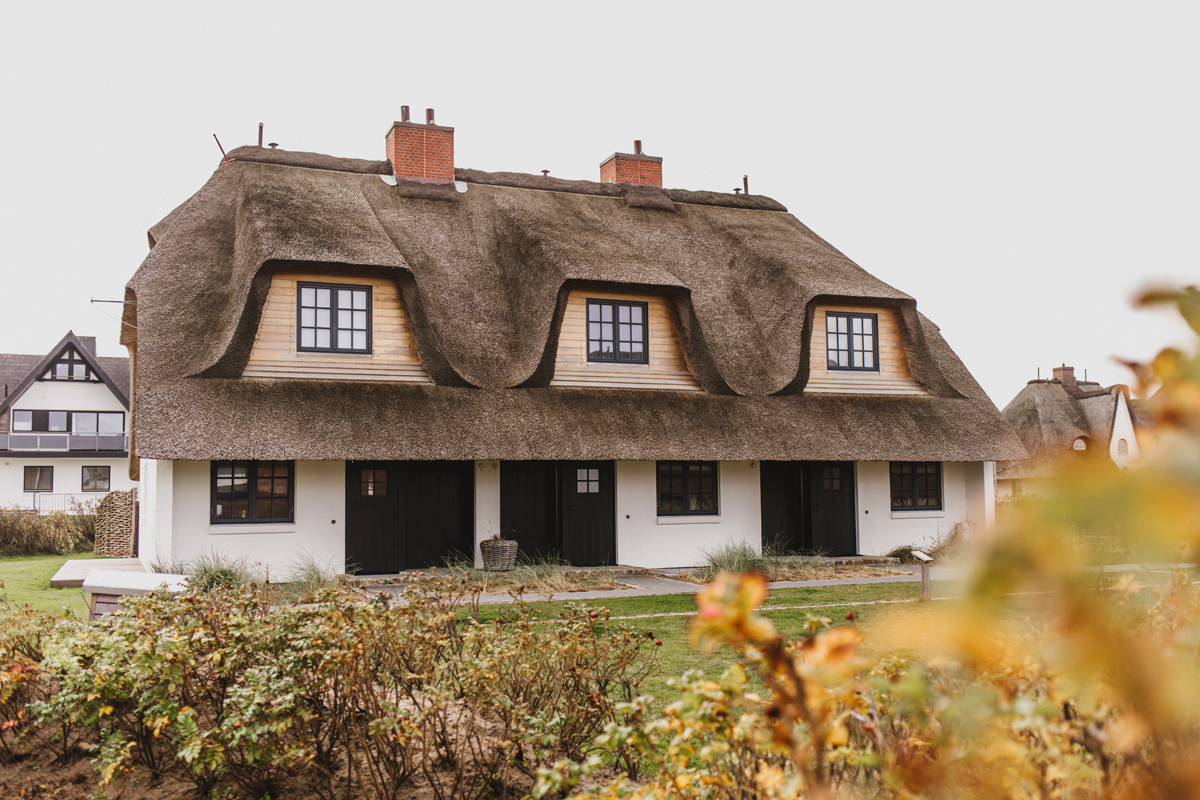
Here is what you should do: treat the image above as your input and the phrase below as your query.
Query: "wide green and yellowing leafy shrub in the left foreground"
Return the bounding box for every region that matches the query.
[23,577,653,798]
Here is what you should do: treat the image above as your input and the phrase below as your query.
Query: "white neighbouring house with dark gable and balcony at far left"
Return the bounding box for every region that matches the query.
[0,332,136,511]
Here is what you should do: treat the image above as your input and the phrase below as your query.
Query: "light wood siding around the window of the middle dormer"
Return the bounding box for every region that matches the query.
[550,290,703,392]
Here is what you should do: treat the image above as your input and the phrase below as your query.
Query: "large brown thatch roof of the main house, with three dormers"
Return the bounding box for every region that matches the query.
[122,148,1024,461]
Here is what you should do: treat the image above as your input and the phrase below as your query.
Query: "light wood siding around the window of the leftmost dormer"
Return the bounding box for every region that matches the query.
[241,272,433,384]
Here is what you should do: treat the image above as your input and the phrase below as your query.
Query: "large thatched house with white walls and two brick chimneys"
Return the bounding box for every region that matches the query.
[122,109,1025,575]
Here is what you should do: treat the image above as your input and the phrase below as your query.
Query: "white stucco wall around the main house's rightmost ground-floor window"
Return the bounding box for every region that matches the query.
[856,461,995,555]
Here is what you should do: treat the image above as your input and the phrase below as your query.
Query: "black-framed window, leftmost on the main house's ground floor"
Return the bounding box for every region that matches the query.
[210,461,294,524]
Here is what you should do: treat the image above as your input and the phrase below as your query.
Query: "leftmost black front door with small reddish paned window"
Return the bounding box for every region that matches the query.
[346,461,404,575]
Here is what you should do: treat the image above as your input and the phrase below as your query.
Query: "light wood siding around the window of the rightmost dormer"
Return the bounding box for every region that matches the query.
[804,306,928,395]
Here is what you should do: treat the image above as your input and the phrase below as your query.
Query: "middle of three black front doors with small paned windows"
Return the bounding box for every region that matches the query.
[558,461,617,566]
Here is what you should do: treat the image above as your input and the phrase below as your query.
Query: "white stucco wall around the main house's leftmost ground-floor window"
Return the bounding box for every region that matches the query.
[150,461,346,581]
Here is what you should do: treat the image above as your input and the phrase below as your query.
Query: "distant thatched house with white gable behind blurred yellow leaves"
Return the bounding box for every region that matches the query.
[996,365,1152,498]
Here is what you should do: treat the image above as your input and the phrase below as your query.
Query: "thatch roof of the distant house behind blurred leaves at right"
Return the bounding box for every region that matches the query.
[996,380,1129,479]
